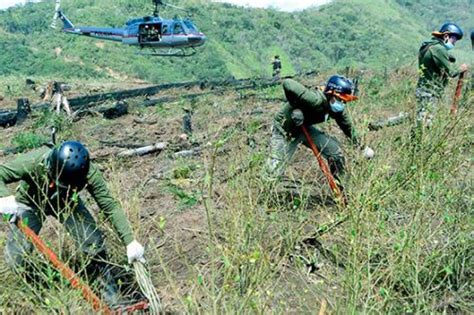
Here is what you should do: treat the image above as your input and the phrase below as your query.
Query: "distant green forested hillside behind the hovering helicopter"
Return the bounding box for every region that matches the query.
[0,0,474,82]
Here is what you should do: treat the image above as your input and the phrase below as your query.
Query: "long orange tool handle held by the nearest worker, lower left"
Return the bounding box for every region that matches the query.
[17,220,112,315]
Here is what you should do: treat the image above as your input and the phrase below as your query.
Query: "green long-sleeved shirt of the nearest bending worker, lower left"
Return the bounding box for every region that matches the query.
[0,147,133,245]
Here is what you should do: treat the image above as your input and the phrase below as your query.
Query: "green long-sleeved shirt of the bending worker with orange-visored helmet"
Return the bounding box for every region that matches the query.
[275,79,359,145]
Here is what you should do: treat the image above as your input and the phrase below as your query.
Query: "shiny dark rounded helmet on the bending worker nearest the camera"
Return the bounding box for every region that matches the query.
[49,141,90,190]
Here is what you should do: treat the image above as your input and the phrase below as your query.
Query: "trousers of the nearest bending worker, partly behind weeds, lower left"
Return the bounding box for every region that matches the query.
[5,200,105,269]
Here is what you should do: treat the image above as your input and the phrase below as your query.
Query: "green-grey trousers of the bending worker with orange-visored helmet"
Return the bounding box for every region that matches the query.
[267,125,344,178]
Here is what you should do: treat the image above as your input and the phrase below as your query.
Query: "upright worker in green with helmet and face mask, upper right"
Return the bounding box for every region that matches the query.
[416,23,469,127]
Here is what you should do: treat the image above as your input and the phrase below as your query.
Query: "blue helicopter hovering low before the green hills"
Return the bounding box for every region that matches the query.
[51,0,207,57]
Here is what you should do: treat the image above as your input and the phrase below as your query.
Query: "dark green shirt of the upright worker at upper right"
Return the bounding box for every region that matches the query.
[417,38,459,96]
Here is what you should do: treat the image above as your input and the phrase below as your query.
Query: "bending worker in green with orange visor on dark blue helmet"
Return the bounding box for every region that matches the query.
[267,75,374,188]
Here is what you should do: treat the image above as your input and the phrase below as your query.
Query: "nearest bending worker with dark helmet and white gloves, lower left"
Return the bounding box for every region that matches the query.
[0,141,144,306]
